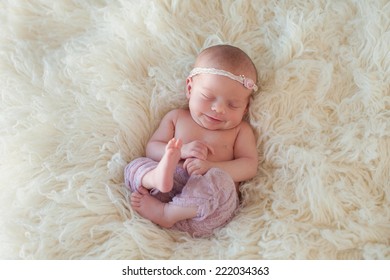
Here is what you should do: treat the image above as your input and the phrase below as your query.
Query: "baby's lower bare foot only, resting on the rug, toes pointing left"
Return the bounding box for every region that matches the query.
[131,187,174,228]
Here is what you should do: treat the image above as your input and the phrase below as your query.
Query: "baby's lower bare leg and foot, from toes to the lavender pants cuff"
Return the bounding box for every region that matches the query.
[131,187,198,228]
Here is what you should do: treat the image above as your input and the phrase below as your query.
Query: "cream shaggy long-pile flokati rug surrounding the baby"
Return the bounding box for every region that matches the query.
[0,0,390,259]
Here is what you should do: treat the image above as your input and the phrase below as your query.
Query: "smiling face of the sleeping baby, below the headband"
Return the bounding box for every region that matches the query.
[187,74,251,130]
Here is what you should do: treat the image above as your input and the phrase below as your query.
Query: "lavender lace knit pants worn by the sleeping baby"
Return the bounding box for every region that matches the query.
[124,158,239,237]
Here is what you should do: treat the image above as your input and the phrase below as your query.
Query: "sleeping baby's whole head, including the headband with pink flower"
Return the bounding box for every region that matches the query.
[187,45,257,130]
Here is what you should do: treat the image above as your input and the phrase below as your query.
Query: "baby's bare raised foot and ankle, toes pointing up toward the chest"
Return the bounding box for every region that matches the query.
[142,138,182,193]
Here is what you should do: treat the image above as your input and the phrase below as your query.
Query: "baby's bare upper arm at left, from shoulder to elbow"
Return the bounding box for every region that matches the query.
[146,110,178,161]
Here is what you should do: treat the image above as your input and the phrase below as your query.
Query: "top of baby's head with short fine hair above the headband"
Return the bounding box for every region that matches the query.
[195,45,257,83]
